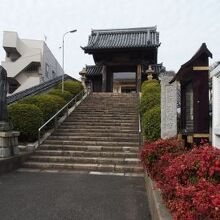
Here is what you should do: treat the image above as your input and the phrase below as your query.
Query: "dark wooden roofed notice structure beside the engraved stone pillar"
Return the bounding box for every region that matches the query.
[170,43,212,146]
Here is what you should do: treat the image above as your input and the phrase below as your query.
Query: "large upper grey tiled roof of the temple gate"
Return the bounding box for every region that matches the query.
[83,26,160,52]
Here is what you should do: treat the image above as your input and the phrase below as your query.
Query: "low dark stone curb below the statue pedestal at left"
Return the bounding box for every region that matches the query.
[0,153,31,175]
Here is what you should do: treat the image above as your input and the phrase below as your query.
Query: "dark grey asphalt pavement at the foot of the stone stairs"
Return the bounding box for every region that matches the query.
[0,172,150,220]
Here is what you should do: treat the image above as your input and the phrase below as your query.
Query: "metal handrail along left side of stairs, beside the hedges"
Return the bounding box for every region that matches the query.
[38,90,90,147]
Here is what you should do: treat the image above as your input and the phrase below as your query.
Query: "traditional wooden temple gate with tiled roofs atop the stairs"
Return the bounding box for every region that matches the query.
[80,26,165,92]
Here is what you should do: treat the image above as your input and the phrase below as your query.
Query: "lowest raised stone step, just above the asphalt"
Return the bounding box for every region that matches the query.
[23,161,143,173]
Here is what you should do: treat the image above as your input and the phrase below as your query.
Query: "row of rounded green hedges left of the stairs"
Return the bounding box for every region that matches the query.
[8,80,83,141]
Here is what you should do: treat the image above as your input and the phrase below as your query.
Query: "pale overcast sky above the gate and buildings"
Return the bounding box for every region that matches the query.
[0,0,220,78]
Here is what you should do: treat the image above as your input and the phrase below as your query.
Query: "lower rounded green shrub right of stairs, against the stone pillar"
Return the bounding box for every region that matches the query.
[142,106,160,140]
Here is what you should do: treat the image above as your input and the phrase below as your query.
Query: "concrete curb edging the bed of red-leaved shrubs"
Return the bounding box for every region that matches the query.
[144,173,173,220]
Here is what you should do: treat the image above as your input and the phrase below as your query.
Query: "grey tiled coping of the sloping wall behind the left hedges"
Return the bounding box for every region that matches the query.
[7,74,75,104]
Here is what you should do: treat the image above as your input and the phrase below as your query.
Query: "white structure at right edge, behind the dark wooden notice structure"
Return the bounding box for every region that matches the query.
[210,64,220,148]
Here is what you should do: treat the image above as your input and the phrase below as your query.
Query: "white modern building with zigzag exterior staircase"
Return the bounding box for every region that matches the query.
[1,31,63,94]
